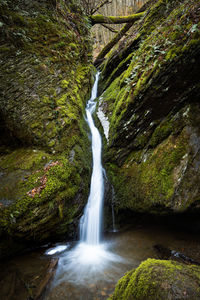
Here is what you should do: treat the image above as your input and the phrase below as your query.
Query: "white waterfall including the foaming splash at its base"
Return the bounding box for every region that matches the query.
[47,73,122,285]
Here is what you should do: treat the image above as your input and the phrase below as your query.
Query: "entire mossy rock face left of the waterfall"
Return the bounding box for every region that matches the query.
[0,0,92,256]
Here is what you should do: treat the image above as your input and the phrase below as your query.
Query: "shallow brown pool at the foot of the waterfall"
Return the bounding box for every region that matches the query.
[45,225,200,300]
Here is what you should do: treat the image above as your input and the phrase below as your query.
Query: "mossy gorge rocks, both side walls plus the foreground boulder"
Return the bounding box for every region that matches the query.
[0,0,200,300]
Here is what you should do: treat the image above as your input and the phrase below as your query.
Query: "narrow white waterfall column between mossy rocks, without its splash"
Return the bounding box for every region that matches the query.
[80,73,104,245]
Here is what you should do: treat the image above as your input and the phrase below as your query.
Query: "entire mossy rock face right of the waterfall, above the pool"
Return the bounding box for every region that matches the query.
[100,0,200,213]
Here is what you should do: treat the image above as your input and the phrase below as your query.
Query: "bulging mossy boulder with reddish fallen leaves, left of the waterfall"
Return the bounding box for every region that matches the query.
[0,141,91,256]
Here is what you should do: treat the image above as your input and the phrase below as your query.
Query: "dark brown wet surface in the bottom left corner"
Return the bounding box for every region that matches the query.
[0,251,51,299]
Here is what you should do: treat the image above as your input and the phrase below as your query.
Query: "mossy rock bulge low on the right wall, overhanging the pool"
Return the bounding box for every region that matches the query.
[106,105,200,214]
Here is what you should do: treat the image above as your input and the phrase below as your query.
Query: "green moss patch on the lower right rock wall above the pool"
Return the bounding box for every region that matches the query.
[108,127,188,212]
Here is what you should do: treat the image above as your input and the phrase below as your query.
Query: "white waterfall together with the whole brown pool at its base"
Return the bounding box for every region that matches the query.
[0,74,200,300]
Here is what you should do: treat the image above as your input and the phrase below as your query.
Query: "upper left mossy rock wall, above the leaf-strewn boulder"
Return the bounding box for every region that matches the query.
[0,1,91,150]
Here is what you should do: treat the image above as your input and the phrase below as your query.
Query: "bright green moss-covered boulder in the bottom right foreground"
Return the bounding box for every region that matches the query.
[109,259,200,300]
